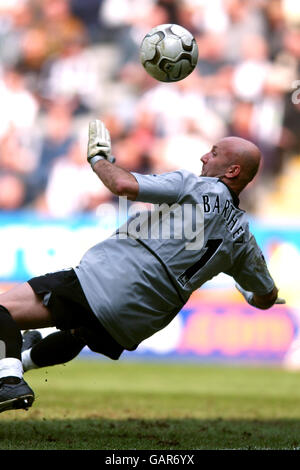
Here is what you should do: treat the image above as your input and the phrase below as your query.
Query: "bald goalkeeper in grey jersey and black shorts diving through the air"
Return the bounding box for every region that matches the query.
[0,120,284,411]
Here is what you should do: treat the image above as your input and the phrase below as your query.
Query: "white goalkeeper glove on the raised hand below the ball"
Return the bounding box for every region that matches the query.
[87,119,116,169]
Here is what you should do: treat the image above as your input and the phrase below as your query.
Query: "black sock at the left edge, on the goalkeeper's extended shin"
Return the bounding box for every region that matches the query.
[0,305,22,360]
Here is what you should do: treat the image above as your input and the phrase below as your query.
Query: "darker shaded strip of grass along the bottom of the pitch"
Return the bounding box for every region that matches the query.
[0,416,300,450]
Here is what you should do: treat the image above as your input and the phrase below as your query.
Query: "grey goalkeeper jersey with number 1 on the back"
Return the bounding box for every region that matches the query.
[75,170,274,349]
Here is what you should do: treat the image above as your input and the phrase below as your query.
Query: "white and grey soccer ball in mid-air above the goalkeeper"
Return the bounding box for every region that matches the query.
[140,24,198,82]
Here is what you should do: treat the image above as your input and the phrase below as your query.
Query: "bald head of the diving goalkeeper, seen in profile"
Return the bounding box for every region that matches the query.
[201,137,261,194]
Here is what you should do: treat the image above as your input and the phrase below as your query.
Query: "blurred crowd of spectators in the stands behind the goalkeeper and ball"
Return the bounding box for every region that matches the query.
[0,0,300,220]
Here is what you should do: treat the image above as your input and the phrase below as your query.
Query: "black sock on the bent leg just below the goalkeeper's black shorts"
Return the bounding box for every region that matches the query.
[30,331,86,367]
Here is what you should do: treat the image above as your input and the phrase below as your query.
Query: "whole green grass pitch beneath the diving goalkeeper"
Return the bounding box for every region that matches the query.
[0,358,300,450]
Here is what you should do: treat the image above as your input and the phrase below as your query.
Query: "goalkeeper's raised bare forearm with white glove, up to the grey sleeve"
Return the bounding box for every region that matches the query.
[87,119,139,201]
